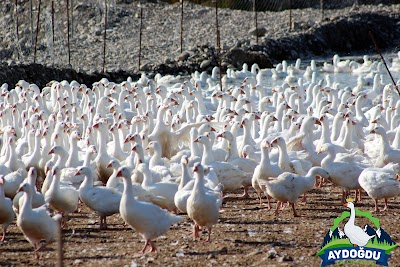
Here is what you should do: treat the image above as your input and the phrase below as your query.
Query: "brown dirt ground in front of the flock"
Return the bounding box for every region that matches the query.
[0,185,400,267]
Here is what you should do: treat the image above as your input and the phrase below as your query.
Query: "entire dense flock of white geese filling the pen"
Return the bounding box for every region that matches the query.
[0,52,400,256]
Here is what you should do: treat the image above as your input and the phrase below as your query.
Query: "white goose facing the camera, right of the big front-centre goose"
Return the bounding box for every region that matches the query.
[186,163,222,242]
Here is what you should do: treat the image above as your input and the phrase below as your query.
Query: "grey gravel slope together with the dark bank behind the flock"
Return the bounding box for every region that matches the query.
[0,0,400,85]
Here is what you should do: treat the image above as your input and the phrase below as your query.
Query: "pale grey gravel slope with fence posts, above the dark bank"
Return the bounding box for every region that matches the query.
[0,0,396,71]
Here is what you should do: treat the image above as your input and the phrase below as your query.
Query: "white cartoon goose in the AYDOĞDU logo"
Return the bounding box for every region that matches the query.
[344,199,375,247]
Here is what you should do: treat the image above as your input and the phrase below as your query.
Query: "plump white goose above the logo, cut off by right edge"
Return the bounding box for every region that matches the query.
[358,164,400,212]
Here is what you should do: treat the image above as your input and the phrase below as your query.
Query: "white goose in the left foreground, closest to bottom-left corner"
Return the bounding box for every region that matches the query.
[17,183,62,258]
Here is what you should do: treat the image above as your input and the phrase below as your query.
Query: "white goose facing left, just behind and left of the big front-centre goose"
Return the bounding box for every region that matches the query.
[76,167,122,229]
